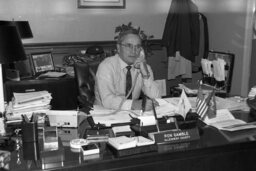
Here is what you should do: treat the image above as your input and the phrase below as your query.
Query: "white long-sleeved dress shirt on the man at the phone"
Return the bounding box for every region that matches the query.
[95,54,160,110]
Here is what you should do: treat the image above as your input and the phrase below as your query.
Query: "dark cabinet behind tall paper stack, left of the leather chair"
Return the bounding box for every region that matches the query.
[5,77,78,110]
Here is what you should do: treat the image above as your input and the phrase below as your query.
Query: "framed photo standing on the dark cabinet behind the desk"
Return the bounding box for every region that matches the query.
[31,52,54,75]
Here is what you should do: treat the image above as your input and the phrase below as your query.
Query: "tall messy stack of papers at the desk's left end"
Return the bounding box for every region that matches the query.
[6,91,52,120]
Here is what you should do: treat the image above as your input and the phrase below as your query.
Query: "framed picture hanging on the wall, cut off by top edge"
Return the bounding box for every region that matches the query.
[78,0,125,8]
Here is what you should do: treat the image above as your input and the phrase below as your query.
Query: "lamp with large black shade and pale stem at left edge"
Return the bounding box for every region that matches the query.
[0,25,26,112]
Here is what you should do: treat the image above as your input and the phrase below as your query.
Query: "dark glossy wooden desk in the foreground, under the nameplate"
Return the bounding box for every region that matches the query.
[4,113,256,171]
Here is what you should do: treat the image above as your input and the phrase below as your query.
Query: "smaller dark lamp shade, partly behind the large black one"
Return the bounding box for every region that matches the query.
[15,21,33,39]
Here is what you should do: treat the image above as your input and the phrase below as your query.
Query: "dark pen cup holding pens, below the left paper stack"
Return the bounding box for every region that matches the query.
[21,122,38,143]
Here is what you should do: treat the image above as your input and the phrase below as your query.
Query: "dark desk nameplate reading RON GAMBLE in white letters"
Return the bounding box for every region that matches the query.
[148,128,200,144]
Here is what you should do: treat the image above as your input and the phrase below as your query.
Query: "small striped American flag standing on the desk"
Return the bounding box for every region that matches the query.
[196,84,209,117]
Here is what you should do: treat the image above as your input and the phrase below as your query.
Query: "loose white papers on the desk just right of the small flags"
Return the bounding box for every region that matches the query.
[204,109,256,131]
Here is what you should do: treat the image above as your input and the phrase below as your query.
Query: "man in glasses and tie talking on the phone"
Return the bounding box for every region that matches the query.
[95,24,160,110]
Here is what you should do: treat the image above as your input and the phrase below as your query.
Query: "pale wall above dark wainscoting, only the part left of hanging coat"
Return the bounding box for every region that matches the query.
[0,0,171,43]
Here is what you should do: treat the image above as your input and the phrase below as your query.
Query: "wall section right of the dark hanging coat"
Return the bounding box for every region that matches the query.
[196,0,254,96]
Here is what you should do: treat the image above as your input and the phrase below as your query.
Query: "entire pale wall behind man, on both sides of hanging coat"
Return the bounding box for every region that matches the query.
[0,0,254,96]
